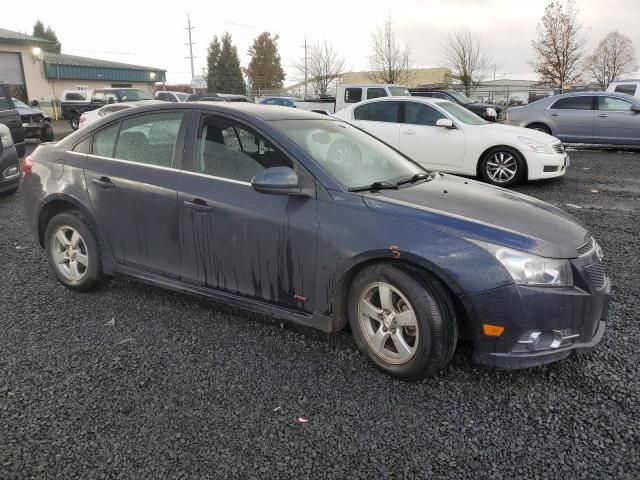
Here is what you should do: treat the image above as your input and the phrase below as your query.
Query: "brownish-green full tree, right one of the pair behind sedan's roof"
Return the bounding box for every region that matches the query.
[247,32,285,90]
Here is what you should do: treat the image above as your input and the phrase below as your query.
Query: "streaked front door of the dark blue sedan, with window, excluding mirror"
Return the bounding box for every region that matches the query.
[178,113,318,312]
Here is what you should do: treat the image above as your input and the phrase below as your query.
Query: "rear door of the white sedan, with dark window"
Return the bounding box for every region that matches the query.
[353,101,400,148]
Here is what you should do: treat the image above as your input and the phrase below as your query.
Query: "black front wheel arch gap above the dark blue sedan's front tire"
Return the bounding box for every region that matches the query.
[330,252,471,337]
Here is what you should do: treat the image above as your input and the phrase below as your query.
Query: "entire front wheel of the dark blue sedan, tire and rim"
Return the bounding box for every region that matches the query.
[348,263,458,381]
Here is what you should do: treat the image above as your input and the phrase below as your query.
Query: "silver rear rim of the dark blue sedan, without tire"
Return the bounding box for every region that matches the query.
[51,225,89,282]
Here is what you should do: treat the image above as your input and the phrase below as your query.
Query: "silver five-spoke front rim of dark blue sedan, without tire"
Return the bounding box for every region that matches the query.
[358,282,419,365]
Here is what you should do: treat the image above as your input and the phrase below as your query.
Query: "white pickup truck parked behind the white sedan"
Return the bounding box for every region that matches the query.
[296,84,411,114]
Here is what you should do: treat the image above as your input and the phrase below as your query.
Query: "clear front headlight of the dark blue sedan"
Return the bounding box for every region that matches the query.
[471,240,573,287]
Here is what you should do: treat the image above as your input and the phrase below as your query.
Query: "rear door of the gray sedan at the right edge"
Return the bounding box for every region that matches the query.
[545,95,597,142]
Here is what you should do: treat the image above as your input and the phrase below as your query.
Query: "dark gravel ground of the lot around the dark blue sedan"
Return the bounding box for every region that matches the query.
[0,150,640,479]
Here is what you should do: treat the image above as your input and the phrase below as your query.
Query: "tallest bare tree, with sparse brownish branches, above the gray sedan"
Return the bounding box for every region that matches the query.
[530,0,586,90]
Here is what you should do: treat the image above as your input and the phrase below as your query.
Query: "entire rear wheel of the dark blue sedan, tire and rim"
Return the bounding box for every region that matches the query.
[44,211,105,292]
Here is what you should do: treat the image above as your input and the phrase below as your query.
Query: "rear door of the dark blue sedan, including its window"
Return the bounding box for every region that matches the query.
[85,111,186,278]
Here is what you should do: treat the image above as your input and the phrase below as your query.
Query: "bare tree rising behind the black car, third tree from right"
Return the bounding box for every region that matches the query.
[443,27,494,95]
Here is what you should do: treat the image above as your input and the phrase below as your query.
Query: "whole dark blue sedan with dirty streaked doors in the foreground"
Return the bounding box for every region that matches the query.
[23,102,610,379]
